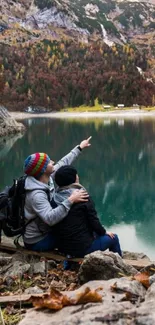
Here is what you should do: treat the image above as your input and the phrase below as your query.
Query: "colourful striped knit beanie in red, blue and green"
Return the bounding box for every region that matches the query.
[24,152,50,178]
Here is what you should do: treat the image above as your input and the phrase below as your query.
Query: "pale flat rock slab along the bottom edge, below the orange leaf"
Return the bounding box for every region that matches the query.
[19,302,155,325]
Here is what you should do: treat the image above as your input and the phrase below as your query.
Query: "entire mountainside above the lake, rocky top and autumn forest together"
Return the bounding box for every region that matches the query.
[0,0,155,109]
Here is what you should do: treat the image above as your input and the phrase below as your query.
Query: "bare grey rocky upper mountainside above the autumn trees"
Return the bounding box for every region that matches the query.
[0,0,155,48]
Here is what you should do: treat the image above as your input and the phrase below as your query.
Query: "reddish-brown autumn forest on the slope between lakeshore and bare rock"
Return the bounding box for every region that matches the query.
[0,39,155,111]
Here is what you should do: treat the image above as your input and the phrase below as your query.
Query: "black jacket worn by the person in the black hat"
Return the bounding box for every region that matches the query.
[52,199,106,257]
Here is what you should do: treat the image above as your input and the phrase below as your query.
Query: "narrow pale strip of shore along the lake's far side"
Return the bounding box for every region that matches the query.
[10,109,155,120]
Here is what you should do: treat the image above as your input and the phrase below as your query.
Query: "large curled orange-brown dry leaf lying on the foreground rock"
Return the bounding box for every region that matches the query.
[29,287,102,310]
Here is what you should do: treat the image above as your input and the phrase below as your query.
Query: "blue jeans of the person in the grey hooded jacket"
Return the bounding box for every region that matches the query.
[24,233,56,252]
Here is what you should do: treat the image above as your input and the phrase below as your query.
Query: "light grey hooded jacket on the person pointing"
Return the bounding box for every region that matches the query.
[23,146,81,244]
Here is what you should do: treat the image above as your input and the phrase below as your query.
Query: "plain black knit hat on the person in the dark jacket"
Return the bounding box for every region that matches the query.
[55,165,77,187]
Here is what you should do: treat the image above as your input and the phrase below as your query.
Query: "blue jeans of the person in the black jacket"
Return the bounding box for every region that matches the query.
[86,234,122,256]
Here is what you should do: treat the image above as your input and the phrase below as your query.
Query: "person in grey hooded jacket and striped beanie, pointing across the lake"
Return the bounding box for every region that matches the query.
[23,137,91,251]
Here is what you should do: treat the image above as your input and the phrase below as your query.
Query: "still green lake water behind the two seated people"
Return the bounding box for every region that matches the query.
[0,118,155,259]
